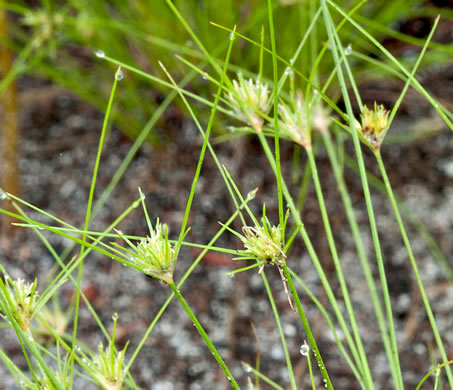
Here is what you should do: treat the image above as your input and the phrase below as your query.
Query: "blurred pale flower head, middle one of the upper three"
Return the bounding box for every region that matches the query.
[278,93,311,149]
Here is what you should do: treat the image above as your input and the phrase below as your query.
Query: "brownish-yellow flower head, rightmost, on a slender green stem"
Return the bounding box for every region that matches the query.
[356,102,389,151]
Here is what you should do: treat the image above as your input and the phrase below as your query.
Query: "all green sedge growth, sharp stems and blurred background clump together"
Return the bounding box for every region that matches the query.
[0,0,453,390]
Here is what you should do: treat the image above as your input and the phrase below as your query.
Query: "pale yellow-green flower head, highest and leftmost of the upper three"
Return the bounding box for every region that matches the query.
[227,73,270,132]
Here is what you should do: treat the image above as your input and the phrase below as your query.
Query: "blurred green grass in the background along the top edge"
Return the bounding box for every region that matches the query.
[4,0,453,143]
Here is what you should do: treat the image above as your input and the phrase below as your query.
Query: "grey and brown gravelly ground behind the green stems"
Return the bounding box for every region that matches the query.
[0,71,453,390]
